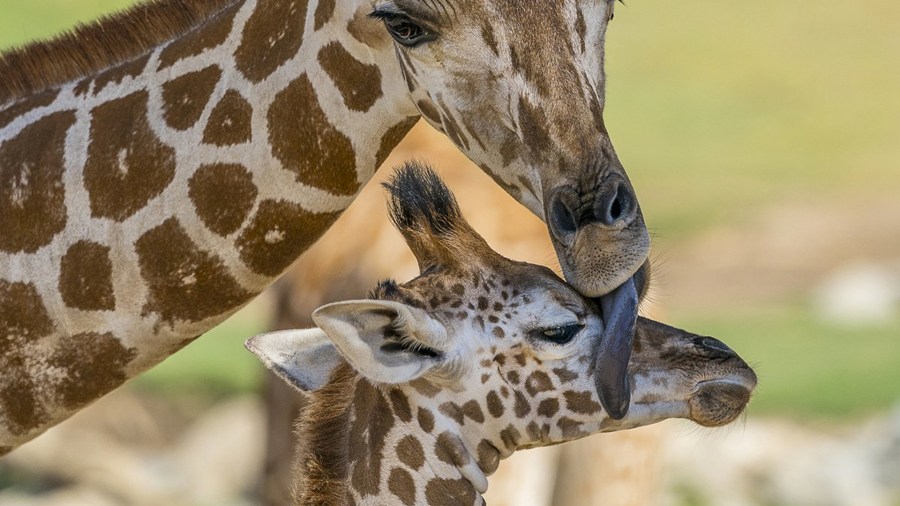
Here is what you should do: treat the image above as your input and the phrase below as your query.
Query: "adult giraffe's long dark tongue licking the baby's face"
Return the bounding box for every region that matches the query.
[594,277,638,420]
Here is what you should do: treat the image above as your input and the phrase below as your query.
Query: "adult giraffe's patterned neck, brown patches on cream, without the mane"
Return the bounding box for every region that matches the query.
[0,0,418,454]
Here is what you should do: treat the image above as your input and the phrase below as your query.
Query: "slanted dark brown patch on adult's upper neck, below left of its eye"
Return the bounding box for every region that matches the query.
[319,42,384,112]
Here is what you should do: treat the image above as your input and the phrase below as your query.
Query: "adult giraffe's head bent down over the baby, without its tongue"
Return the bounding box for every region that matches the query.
[372,0,650,296]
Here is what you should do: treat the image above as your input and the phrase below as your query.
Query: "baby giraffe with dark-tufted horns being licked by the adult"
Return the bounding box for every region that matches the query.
[247,165,756,506]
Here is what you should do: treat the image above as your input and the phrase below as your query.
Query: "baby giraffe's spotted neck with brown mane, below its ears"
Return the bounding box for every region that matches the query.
[294,364,486,506]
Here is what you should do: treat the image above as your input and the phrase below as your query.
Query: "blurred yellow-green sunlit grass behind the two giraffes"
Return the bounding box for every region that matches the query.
[0,0,900,420]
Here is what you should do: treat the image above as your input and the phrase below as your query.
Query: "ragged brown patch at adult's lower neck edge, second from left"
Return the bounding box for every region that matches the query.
[49,333,137,409]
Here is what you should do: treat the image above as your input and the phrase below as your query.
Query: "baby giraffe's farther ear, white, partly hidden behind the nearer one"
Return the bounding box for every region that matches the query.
[244,329,342,393]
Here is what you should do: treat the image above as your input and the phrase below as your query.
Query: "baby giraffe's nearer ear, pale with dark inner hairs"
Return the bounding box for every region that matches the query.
[313,300,449,384]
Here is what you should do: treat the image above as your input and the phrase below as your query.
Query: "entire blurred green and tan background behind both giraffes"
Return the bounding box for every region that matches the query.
[0,0,900,506]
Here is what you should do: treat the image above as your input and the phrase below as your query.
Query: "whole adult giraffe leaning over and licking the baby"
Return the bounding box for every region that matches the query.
[0,0,649,455]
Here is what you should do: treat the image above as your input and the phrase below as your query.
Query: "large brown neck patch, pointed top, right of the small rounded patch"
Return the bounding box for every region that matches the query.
[268,75,360,195]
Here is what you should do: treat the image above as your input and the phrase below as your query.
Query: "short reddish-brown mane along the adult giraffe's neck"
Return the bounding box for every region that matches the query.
[0,0,239,105]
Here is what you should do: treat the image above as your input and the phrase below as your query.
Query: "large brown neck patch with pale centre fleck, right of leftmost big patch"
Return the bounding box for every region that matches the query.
[84,91,175,222]
